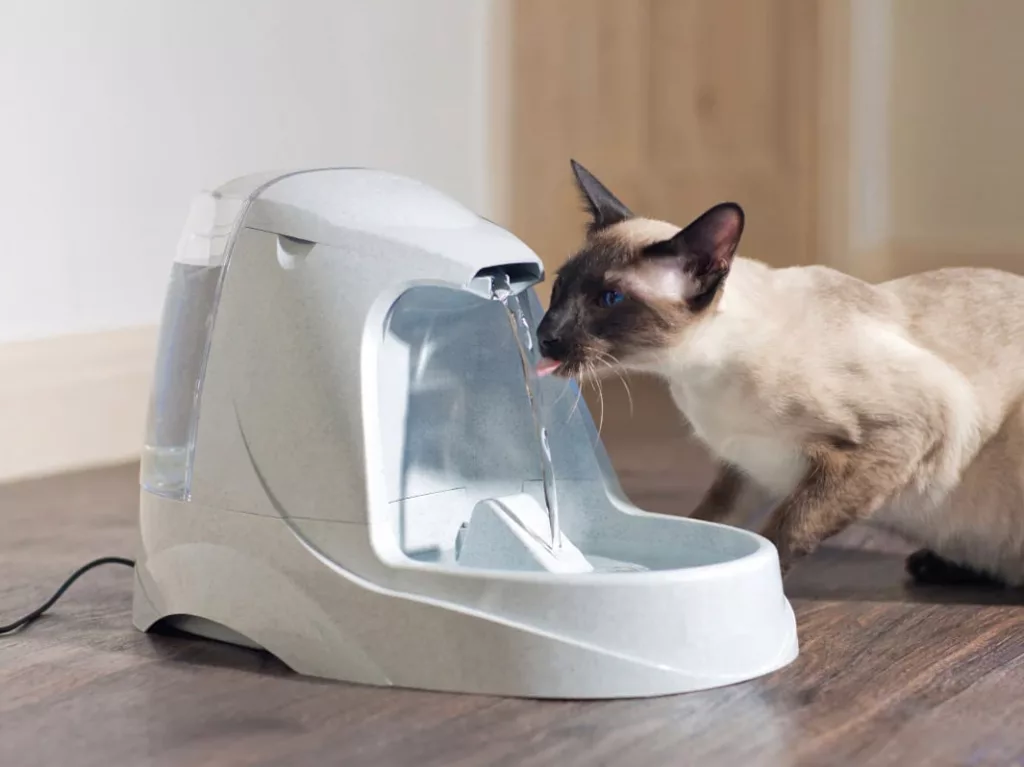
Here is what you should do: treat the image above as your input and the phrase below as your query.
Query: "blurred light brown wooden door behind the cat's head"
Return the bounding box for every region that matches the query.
[510,0,829,300]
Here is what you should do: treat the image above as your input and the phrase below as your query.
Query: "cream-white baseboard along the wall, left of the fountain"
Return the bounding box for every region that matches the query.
[0,328,157,481]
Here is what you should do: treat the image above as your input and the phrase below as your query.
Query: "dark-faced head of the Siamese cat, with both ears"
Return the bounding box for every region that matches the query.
[537,160,743,377]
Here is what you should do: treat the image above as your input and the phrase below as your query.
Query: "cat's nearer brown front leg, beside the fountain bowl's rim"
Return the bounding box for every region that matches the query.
[761,440,920,574]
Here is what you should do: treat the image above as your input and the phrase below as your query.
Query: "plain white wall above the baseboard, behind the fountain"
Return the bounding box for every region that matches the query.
[0,0,498,343]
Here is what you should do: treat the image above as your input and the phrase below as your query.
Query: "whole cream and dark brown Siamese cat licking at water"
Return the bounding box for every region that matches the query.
[538,161,1024,586]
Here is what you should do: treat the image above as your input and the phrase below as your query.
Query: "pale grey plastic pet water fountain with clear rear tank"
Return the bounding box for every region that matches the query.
[134,169,797,698]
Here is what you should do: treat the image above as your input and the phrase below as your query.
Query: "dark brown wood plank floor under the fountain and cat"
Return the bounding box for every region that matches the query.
[0,403,1024,767]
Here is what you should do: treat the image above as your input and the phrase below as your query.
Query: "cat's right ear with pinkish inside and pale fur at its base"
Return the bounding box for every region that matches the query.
[626,203,743,310]
